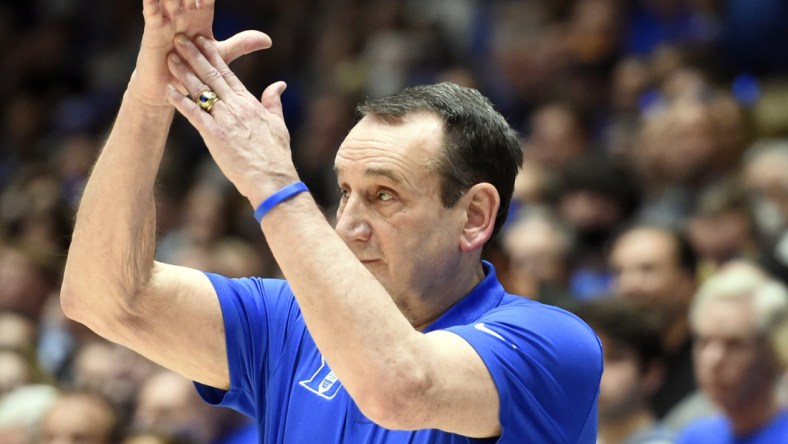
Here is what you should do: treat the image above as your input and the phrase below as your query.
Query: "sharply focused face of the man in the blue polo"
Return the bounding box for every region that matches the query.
[335,113,465,308]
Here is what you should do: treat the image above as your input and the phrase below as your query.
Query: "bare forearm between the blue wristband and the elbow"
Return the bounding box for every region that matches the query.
[262,194,426,417]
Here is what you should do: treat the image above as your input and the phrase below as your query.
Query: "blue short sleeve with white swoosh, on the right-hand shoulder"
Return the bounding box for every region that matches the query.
[448,301,602,443]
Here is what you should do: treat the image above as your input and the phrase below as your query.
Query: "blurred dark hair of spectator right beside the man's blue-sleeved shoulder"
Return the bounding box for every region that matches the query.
[572,296,664,370]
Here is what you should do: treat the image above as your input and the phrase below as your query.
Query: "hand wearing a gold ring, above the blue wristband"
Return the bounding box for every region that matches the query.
[168,35,298,206]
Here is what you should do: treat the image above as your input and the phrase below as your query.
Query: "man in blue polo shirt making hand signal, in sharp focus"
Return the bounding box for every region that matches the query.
[62,0,601,443]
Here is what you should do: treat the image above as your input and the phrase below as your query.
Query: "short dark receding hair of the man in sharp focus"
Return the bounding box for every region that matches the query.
[357,82,523,242]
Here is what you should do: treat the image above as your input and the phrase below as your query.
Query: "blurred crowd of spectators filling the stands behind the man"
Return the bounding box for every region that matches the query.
[0,0,788,444]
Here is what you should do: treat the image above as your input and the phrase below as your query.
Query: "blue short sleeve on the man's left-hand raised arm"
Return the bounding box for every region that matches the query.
[195,273,299,416]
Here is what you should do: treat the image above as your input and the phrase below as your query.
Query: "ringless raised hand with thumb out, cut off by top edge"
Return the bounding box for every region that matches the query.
[129,0,271,107]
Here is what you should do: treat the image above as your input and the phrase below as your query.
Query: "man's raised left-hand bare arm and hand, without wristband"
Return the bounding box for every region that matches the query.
[61,0,270,387]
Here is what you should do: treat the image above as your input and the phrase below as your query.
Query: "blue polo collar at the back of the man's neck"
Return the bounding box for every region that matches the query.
[423,261,505,333]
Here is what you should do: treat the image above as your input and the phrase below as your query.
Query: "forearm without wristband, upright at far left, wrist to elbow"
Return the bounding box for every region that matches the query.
[61,87,173,330]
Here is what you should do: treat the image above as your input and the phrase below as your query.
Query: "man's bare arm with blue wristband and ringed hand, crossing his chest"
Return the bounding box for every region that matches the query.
[169,38,501,437]
